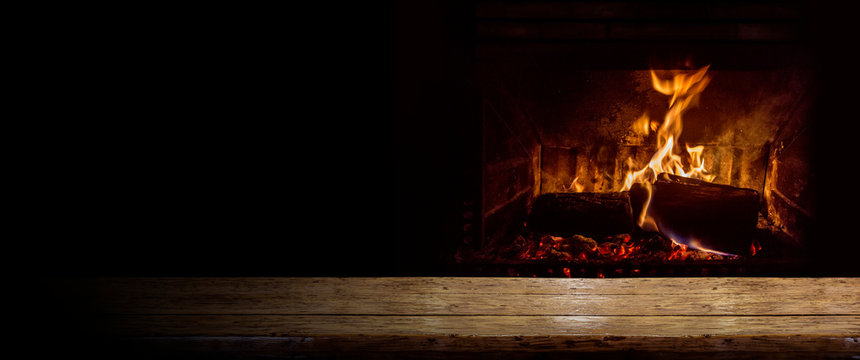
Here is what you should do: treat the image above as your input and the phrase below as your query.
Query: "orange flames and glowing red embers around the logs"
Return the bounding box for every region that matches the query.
[466,66,748,268]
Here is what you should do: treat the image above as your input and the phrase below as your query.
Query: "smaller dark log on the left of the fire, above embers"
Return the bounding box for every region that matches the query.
[527,192,633,238]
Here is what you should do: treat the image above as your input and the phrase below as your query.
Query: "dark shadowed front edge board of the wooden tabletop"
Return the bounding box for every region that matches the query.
[114,336,854,360]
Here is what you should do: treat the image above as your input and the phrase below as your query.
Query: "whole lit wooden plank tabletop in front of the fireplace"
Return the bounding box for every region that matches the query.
[51,277,860,358]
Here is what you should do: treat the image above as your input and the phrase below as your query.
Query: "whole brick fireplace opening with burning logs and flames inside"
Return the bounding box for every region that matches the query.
[449,1,851,277]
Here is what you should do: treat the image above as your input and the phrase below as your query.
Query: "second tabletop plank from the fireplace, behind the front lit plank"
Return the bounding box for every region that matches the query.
[89,293,860,315]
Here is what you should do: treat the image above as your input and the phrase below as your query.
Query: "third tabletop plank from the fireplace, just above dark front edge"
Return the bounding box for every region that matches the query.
[104,315,860,340]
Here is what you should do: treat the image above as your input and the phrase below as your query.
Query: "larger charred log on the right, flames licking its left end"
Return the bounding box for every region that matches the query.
[630,173,759,255]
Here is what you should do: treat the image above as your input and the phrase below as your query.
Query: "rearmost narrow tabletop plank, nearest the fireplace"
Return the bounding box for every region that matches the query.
[75,277,860,297]
